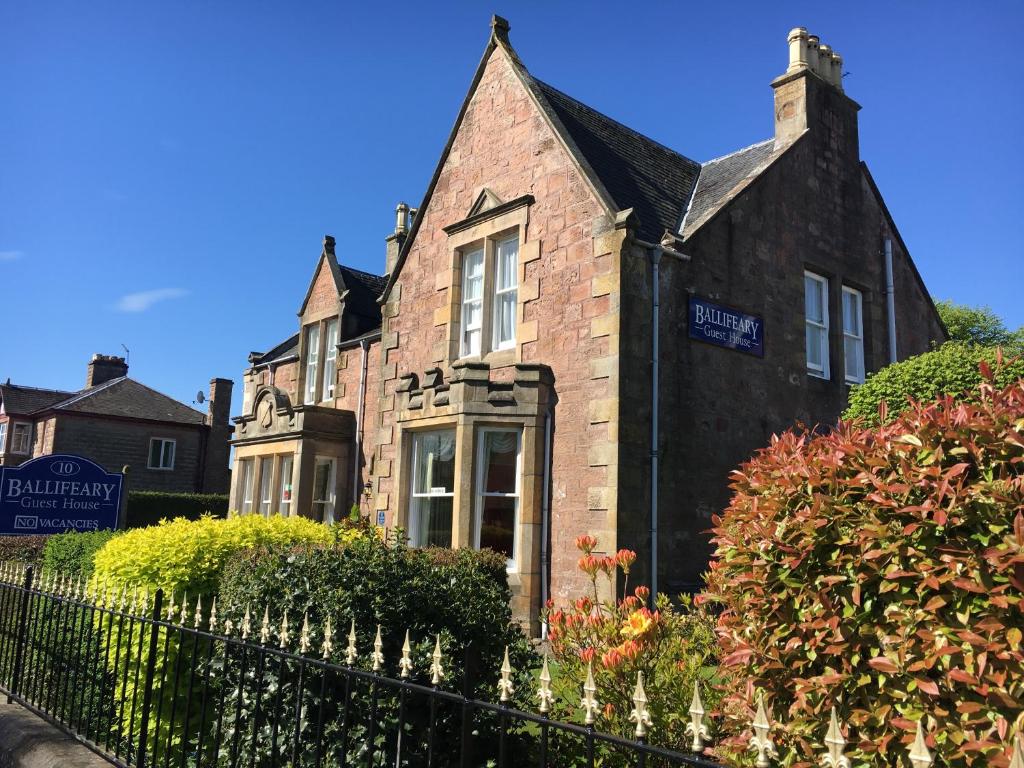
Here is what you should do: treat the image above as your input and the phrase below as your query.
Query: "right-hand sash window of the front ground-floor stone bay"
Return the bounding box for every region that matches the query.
[473,427,520,569]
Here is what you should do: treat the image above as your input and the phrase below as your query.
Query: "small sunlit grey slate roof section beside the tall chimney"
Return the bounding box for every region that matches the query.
[678,138,792,239]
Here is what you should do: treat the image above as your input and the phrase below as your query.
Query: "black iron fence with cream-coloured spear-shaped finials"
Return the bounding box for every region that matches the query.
[0,566,720,768]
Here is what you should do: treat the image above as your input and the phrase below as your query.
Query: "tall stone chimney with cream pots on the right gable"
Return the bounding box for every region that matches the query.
[771,27,860,156]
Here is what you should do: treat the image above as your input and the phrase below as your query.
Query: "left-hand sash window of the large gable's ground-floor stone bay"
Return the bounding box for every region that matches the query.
[409,429,455,547]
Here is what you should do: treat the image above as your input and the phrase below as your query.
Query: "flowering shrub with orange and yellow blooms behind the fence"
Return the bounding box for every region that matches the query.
[547,536,718,762]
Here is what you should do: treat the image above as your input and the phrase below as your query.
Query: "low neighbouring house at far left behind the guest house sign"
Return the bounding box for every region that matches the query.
[0,354,232,494]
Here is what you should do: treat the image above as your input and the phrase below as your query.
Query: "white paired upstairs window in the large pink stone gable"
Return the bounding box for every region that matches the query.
[459,233,519,357]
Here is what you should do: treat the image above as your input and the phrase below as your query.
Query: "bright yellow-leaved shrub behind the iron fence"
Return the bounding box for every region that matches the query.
[93,515,339,757]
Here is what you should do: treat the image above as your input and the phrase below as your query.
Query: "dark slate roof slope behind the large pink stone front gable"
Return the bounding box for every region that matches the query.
[527,76,700,242]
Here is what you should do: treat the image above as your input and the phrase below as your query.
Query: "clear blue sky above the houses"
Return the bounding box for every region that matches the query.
[0,0,1024,421]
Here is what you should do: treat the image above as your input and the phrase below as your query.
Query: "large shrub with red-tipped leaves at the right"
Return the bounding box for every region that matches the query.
[709,370,1024,768]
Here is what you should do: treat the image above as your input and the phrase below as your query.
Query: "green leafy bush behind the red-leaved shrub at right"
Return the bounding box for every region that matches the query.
[843,342,1024,425]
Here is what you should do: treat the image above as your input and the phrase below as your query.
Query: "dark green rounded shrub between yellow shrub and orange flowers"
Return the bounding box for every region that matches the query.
[218,536,537,765]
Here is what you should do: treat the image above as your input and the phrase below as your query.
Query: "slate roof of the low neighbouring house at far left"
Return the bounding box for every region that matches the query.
[0,376,206,424]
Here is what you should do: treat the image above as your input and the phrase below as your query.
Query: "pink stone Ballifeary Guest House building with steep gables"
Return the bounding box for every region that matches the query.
[231,17,946,629]
